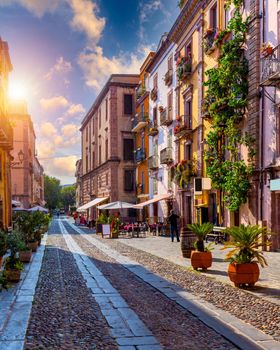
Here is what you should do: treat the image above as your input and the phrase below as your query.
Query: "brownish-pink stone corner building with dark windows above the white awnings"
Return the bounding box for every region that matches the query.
[80,74,139,217]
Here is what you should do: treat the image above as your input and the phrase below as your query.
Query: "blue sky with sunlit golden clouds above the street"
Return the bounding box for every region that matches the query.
[0,0,179,184]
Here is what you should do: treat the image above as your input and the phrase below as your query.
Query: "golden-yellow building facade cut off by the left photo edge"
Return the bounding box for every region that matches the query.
[0,38,13,229]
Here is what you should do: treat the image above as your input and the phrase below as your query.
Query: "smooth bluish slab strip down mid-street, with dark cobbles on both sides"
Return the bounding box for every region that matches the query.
[59,221,162,350]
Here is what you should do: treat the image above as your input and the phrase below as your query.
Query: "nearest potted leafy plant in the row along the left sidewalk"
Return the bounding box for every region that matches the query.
[4,232,23,282]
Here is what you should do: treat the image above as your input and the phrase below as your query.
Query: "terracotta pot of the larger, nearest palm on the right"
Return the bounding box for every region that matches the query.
[228,262,260,287]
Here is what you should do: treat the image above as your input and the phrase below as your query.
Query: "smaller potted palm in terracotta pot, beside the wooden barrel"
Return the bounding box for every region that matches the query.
[188,222,214,270]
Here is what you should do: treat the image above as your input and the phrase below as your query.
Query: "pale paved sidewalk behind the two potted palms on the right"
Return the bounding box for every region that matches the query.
[113,236,280,305]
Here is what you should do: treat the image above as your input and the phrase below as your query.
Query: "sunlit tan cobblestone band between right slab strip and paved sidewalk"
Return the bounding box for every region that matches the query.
[76,227,280,342]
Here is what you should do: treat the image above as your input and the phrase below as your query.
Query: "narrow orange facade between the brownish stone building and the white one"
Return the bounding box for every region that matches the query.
[132,52,154,217]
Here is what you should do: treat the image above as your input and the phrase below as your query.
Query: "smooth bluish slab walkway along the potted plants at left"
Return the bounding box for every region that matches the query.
[0,234,47,350]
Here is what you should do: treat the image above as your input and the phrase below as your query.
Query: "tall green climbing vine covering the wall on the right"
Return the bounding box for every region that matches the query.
[204,0,255,211]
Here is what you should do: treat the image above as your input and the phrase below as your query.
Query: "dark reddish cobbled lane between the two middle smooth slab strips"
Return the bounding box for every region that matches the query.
[64,223,236,350]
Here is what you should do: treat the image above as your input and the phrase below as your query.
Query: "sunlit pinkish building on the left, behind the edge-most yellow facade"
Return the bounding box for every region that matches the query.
[9,101,44,208]
